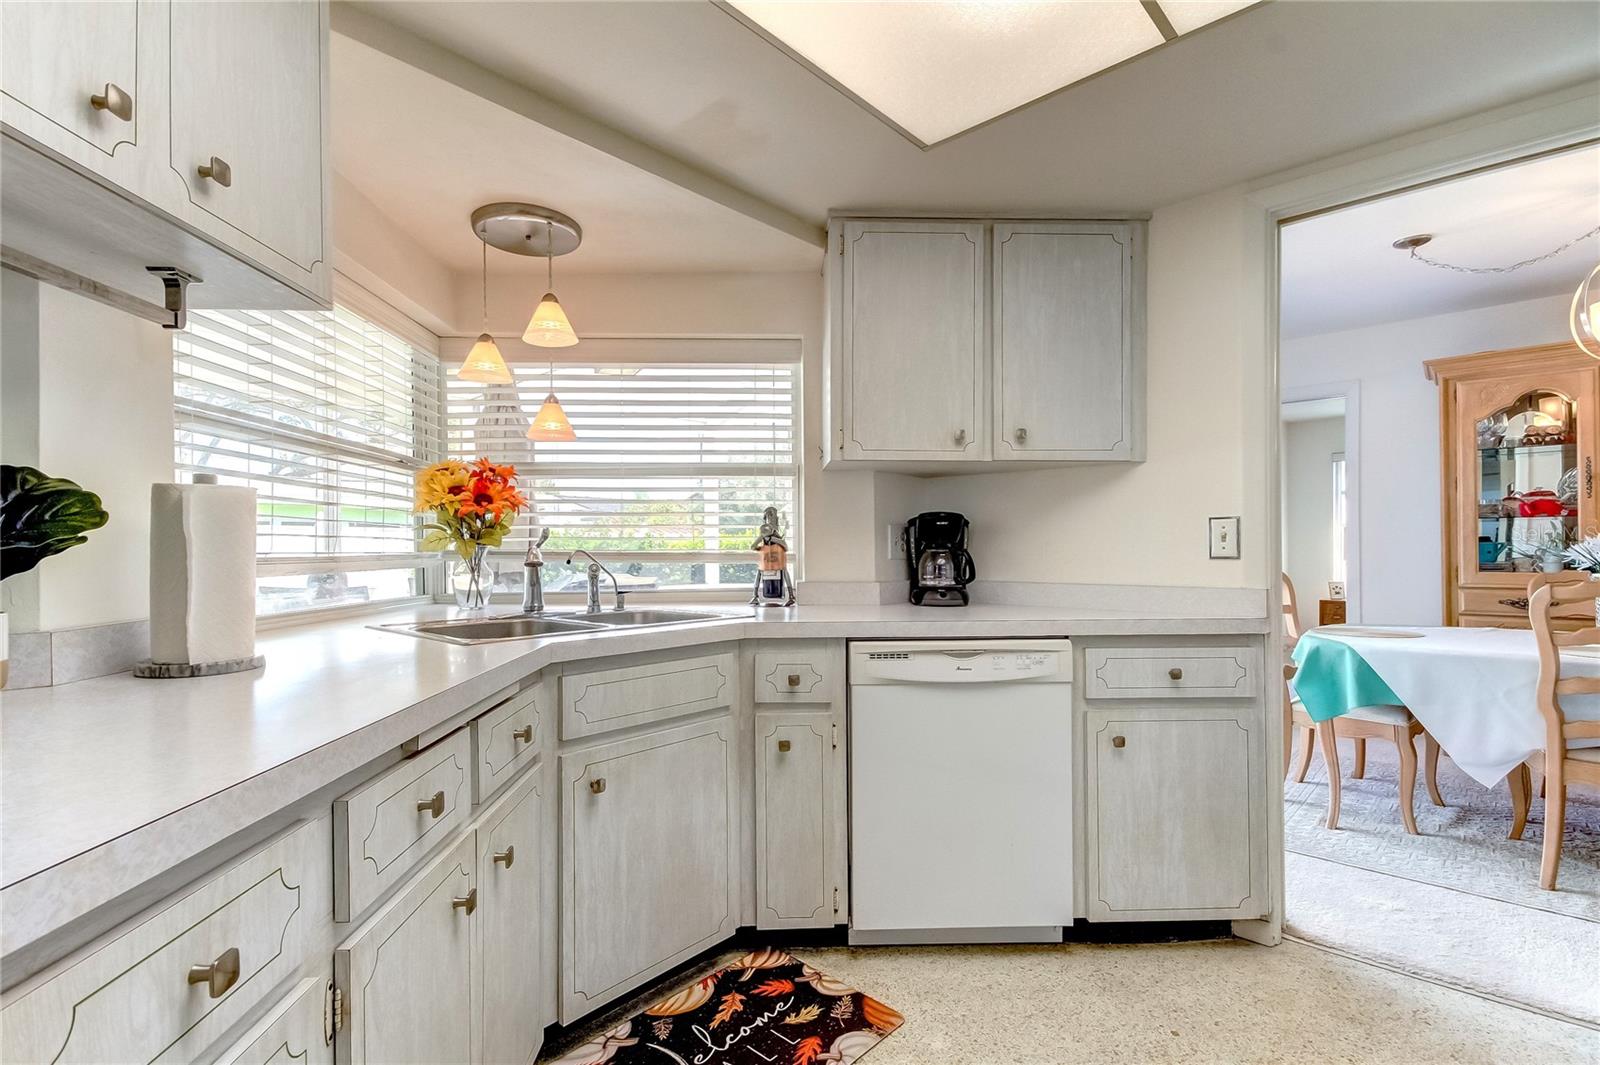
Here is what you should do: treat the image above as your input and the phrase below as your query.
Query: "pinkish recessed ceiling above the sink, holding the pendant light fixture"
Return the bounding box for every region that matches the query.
[331,34,821,277]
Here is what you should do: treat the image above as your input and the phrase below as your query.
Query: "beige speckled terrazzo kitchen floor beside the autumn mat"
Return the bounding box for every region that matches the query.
[546,940,1600,1065]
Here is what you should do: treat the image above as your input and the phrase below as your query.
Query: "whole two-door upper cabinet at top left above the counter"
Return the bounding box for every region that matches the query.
[0,0,331,315]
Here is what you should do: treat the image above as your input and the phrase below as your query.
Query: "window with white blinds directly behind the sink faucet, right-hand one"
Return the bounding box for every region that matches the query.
[446,337,800,598]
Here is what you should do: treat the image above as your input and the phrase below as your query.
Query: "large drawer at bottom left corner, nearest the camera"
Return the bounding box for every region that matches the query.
[0,820,328,1062]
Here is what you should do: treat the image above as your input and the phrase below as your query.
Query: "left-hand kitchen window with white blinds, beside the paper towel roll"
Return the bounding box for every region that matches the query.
[173,286,443,616]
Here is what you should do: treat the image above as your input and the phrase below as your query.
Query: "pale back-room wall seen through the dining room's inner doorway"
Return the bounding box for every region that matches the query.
[1283,417,1344,632]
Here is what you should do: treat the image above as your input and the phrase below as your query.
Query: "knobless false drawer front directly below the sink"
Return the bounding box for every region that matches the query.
[562,654,738,739]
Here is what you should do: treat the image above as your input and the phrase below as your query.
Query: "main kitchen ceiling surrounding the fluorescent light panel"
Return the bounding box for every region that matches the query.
[336,0,1600,222]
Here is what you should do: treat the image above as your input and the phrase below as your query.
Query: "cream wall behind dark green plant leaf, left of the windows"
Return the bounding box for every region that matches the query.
[0,272,173,630]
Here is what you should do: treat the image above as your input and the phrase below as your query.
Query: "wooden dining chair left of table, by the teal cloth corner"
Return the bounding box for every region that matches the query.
[1282,574,1445,836]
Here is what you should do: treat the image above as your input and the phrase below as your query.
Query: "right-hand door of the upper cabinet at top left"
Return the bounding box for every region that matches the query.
[171,0,326,270]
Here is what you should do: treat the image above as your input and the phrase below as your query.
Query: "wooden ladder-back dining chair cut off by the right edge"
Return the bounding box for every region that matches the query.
[1515,580,1600,891]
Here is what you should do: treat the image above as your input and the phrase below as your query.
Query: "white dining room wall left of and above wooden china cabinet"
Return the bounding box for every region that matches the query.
[1280,294,1571,625]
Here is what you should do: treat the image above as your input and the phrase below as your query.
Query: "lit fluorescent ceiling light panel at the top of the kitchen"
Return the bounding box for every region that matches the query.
[726,0,1254,147]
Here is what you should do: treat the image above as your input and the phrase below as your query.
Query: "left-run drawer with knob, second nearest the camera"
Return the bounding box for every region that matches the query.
[333,729,472,921]
